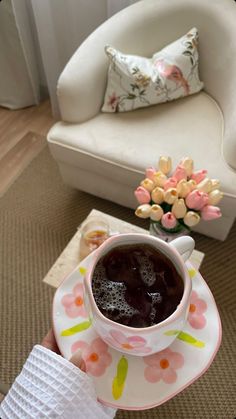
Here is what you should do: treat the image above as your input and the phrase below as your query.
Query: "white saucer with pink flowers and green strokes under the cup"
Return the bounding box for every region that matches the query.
[53,255,221,410]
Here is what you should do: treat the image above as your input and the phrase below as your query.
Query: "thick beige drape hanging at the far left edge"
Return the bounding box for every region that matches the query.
[0,0,39,109]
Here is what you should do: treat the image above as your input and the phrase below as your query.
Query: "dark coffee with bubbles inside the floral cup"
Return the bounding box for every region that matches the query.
[92,243,184,328]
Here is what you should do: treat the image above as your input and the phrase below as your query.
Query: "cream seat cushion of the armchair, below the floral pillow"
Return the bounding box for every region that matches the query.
[48,91,236,202]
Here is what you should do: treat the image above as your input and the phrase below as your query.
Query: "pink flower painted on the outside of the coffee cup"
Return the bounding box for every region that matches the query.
[107,330,151,353]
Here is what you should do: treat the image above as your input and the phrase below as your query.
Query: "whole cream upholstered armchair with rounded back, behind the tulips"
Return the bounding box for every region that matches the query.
[48,0,236,240]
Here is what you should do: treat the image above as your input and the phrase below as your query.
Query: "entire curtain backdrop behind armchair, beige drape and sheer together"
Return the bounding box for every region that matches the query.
[0,0,137,118]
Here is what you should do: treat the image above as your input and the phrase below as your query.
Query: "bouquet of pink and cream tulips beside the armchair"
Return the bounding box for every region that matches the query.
[134,156,223,232]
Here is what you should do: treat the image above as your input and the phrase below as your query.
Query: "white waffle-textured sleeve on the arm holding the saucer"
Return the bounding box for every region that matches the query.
[0,345,116,419]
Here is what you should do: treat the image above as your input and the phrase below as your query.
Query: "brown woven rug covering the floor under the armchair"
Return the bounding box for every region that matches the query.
[0,147,236,419]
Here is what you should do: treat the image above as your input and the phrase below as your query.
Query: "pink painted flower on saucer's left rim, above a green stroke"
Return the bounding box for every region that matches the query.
[61,284,87,318]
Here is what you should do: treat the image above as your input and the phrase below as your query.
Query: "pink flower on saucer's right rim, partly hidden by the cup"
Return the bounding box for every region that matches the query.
[188,291,207,329]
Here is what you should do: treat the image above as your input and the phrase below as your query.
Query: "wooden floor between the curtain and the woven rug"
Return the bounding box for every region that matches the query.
[0,100,55,196]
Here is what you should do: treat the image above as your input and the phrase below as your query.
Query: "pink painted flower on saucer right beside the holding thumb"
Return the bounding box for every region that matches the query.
[71,338,112,377]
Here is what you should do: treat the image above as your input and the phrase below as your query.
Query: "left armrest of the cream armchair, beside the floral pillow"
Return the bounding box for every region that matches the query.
[57,33,108,123]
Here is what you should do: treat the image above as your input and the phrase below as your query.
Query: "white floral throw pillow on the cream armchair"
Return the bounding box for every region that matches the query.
[102,28,203,112]
